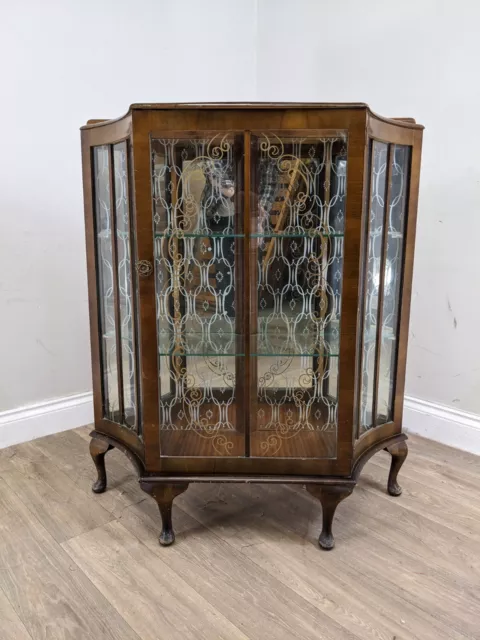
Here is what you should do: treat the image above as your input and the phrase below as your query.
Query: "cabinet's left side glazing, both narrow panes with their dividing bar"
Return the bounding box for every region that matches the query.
[93,141,139,430]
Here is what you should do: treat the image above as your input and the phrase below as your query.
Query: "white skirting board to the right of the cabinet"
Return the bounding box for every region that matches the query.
[403,396,480,455]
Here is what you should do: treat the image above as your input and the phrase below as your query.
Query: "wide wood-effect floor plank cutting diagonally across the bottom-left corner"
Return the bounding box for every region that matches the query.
[0,479,140,640]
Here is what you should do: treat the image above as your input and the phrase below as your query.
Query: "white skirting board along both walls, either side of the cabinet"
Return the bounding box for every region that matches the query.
[0,393,480,455]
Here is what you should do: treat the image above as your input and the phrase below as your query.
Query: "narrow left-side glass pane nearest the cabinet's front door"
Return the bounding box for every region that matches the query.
[113,142,137,428]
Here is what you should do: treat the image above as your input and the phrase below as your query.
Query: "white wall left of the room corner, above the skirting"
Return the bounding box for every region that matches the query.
[0,0,254,412]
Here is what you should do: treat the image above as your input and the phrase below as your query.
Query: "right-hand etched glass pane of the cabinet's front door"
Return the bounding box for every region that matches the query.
[250,132,347,458]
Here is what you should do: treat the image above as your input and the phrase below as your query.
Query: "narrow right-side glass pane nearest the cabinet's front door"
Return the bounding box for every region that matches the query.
[360,141,388,432]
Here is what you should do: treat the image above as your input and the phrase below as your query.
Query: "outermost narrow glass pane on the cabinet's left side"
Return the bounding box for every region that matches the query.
[93,146,119,421]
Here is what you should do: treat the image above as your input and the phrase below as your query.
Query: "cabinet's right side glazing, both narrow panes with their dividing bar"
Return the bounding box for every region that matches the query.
[359,141,411,435]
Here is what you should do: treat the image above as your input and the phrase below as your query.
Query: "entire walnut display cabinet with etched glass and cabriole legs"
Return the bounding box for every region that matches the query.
[81,103,423,549]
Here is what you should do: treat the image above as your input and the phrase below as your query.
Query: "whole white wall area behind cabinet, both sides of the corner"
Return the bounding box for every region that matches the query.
[0,0,480,450]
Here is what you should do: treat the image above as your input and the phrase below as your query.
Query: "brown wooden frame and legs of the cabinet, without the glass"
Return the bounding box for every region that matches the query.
[81,103,423,548]
